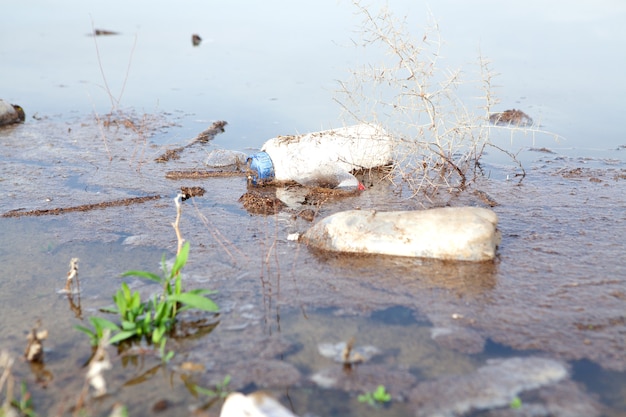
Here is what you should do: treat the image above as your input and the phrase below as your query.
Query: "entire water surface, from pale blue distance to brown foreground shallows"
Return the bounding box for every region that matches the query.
[0,1,626,417]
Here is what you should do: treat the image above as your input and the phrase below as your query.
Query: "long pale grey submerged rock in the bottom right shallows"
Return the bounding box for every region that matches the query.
[409,357,567,417]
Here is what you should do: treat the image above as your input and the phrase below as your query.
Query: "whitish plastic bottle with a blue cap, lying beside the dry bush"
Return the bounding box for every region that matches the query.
[247,124,393,189]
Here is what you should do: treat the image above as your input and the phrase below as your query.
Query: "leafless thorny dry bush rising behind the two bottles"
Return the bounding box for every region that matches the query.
[335,1,514,196]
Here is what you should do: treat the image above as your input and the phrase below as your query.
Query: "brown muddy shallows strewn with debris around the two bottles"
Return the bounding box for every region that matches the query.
[0,114,626,416]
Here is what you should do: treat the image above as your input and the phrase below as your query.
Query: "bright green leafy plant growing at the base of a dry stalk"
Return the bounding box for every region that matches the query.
[76,243,219,352]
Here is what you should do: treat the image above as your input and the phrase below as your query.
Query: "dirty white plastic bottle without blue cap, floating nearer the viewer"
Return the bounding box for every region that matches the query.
[302,207,500,261]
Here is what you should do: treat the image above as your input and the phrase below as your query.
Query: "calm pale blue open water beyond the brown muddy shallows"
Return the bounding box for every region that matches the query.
[0,0,626,159]
